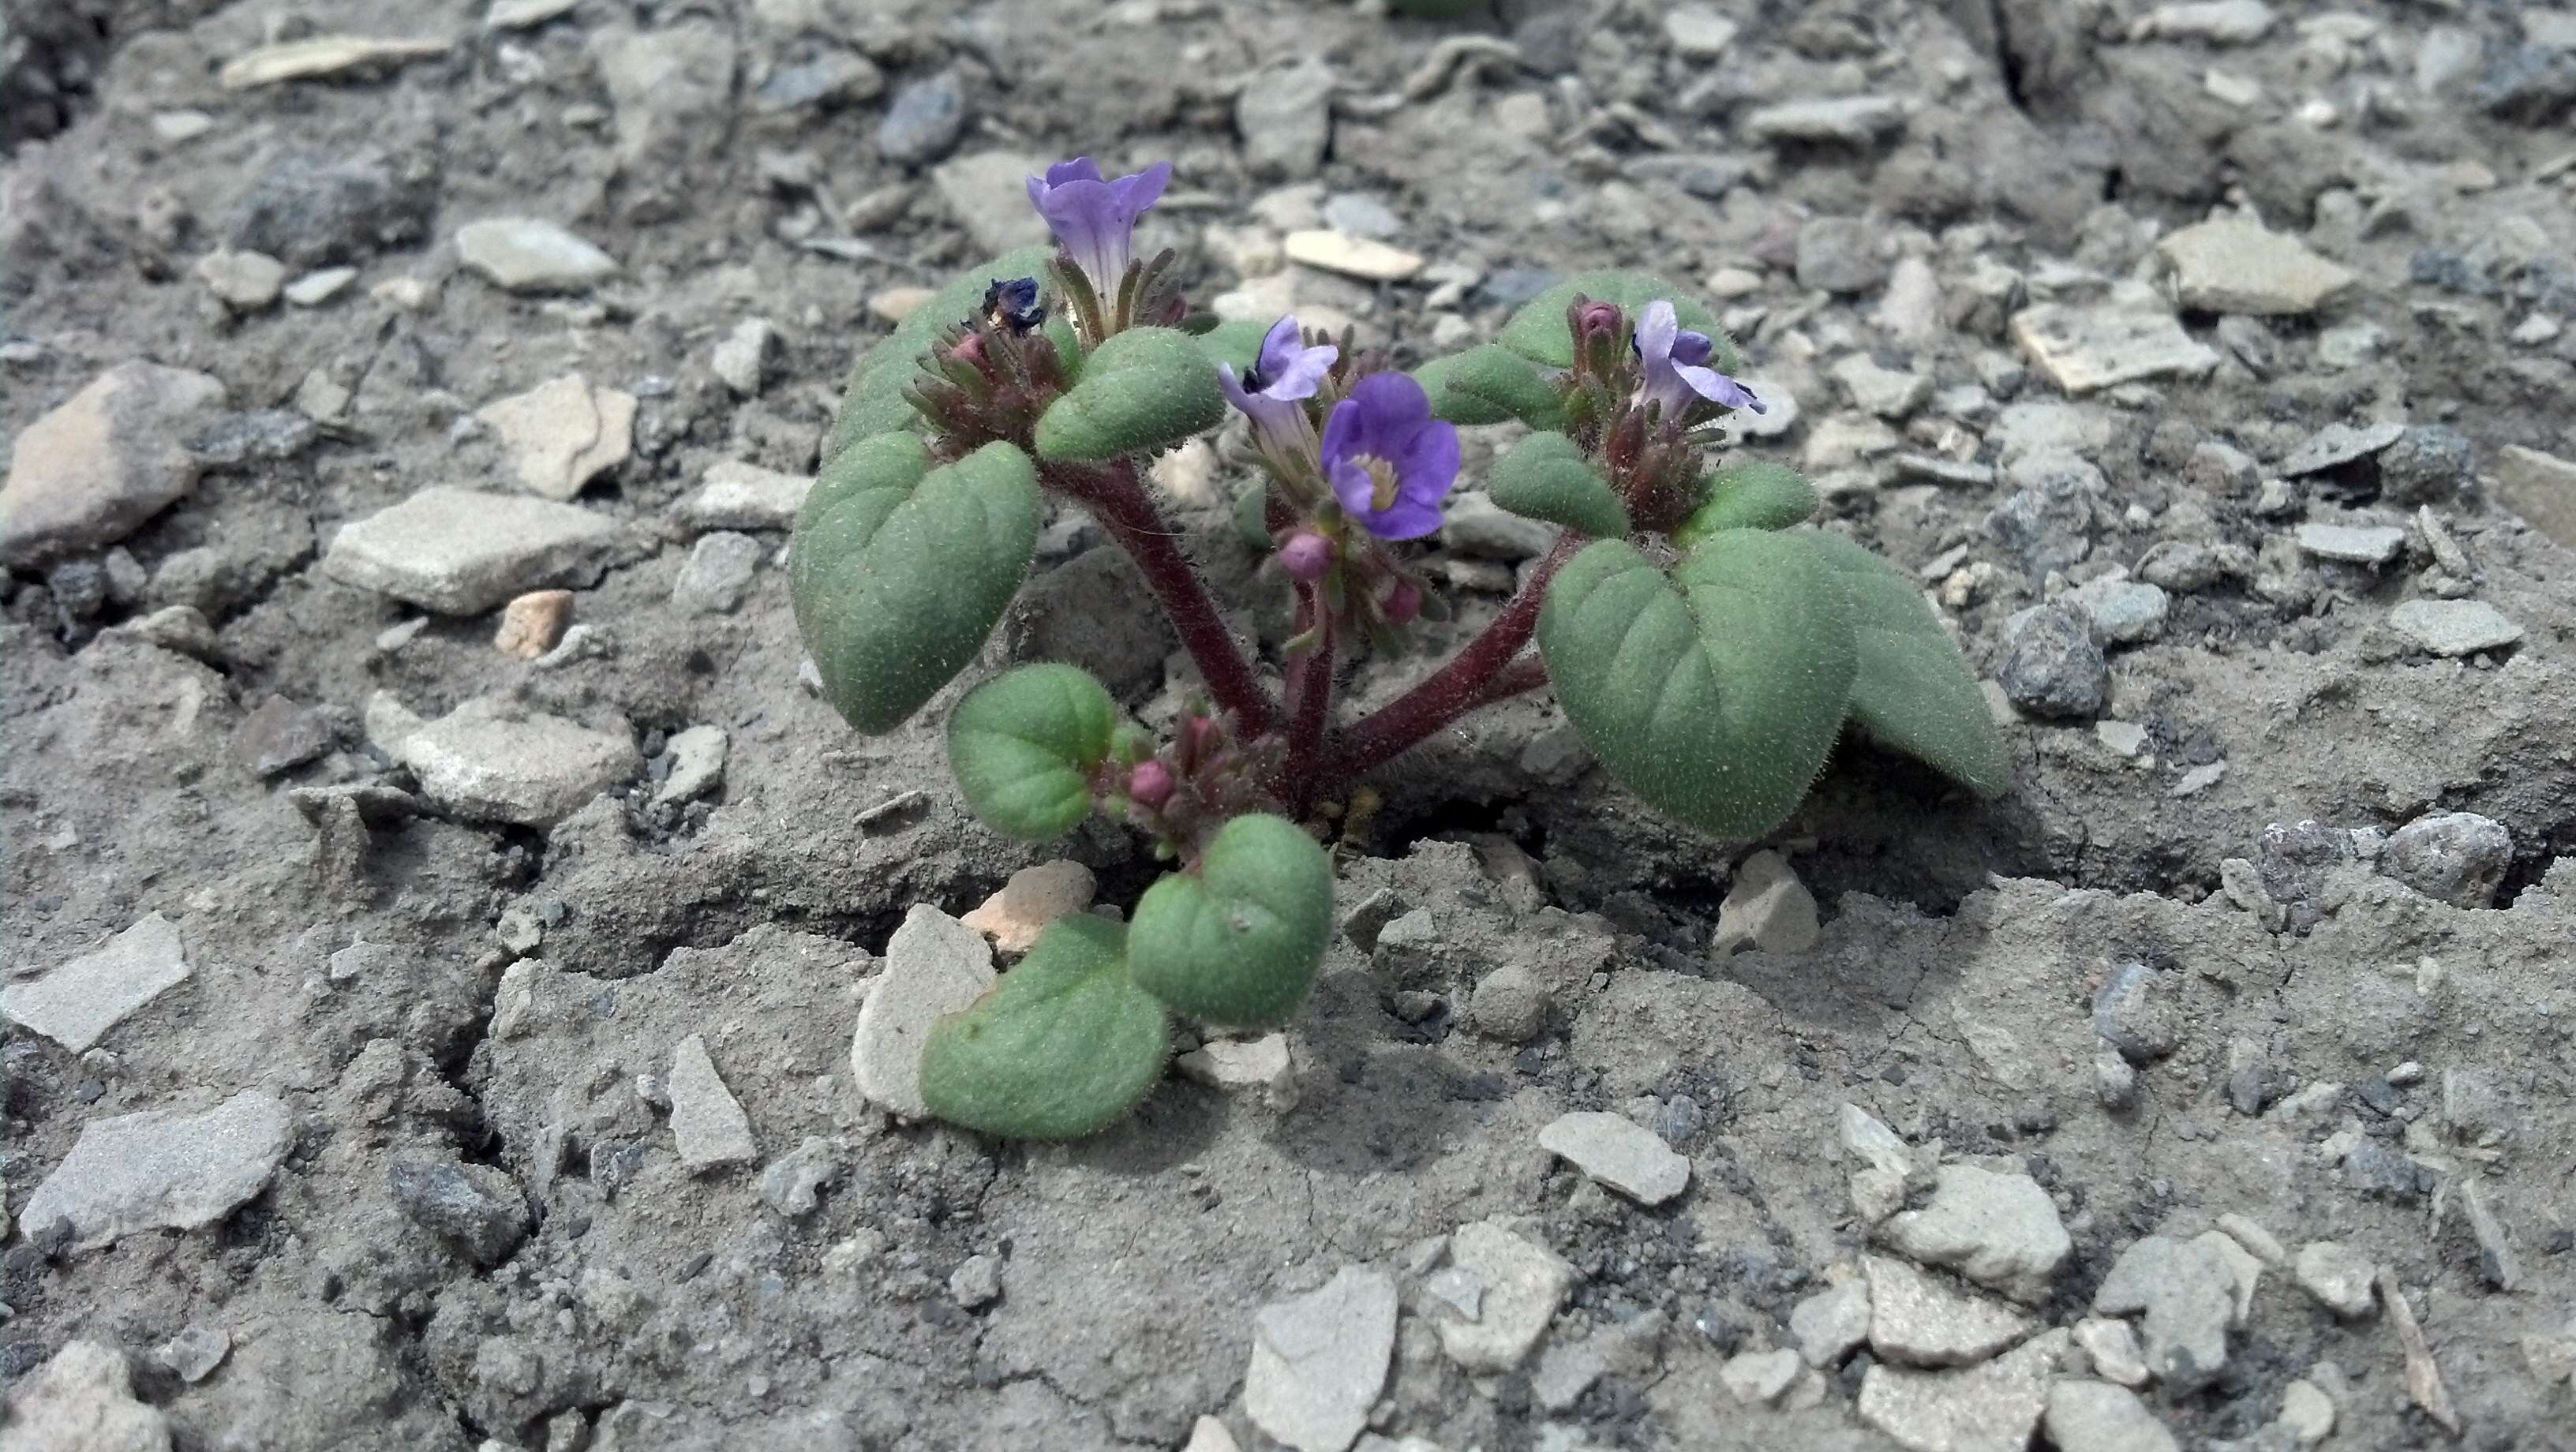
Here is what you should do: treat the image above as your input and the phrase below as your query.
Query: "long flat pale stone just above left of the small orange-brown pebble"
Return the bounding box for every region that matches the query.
[322,487,616,616]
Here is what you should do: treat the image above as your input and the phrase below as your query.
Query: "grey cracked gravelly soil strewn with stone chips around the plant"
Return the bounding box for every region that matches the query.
[0,0,2576,1452]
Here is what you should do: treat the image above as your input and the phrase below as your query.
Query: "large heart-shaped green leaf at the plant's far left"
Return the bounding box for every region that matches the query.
[788,432,1038,734]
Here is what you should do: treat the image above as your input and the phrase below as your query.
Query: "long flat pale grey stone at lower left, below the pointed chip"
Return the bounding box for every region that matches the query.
[18,1089,296,1252]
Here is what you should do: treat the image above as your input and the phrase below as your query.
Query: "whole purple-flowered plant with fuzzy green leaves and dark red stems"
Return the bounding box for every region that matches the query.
[791,159,2007,1138]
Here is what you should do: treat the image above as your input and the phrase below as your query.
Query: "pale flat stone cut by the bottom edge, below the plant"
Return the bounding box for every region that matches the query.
[1245,1267,1396,1452]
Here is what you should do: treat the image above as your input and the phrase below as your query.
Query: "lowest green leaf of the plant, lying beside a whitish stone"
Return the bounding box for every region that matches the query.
[923,914,1170,1140]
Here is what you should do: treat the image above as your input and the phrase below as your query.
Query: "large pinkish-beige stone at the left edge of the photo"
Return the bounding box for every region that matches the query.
[0,363,224,569]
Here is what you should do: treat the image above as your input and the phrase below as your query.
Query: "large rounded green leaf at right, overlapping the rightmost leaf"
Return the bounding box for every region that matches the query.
[1538,530,1857,836]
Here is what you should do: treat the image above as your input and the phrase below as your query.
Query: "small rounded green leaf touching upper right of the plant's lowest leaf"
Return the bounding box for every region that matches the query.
[1129,814,1331,1027]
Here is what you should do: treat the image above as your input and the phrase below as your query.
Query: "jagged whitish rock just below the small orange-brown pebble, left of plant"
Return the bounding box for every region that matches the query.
[365,690,642,826]
